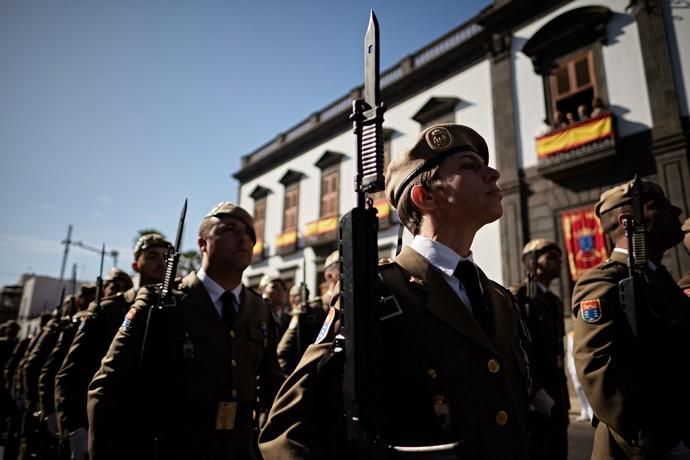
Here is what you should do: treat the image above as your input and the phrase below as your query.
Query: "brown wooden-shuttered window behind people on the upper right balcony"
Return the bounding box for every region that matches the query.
[548,50,599,122]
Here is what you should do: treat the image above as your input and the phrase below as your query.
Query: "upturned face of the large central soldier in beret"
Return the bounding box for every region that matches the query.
[432,152,503,230]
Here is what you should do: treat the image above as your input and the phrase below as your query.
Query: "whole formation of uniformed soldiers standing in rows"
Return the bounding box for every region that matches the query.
[0,120,690,460]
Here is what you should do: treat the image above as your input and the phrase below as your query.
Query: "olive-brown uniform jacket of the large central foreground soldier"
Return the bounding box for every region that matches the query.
[259,248,528,460]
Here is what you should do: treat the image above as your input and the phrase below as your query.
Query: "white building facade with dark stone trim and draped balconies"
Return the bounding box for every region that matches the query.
[234,0,690,304]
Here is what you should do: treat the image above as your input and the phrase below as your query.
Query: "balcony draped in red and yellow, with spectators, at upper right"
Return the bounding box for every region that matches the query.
[535,113,616,179]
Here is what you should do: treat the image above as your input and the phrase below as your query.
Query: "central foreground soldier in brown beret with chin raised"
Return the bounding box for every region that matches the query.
[259,124,528,460]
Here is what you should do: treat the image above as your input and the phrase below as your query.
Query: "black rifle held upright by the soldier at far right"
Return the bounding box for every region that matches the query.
[618,174,648,337]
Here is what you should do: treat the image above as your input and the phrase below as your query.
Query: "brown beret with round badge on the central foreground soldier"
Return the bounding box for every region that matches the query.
[386,123,489,208]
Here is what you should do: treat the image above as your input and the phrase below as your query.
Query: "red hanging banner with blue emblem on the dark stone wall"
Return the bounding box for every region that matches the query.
[561,208,608,281]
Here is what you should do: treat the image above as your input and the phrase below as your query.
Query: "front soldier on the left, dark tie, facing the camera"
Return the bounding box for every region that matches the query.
[87,202,282,460]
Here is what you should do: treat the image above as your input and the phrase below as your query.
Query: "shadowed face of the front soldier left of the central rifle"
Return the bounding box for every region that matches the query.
[199,215,254,271]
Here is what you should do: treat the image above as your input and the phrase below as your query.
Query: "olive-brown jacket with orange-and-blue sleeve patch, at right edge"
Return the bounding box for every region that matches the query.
[573,252,690,459]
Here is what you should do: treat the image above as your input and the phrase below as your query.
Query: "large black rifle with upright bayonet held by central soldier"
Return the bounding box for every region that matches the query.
[334,11,457,459]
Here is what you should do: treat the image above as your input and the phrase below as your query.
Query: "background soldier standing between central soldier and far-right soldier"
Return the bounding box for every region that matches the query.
[511,238,570,460]
